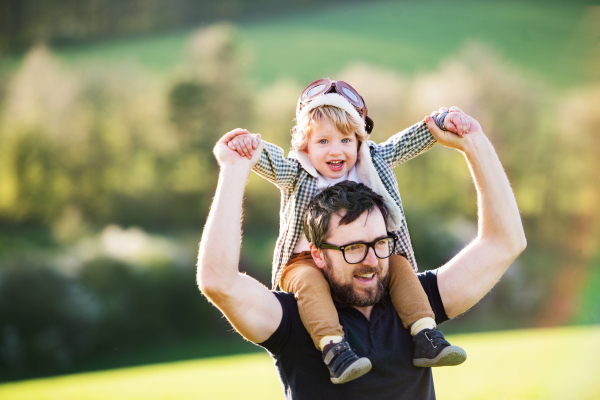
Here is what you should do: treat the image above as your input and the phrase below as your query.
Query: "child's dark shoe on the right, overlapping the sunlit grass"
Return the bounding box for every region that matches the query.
[413,329,467,367]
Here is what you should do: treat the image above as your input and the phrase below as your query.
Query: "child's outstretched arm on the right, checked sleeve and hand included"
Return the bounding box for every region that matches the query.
[375,108,468,168]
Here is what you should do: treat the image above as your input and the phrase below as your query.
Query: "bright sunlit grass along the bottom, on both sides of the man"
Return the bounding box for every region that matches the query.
[0,326,600,400]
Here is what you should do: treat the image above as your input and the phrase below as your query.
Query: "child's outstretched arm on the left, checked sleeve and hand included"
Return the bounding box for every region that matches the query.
[218,129,299,189]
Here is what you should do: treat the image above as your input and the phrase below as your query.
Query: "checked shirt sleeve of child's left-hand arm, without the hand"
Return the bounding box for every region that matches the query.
[253,141,300,190]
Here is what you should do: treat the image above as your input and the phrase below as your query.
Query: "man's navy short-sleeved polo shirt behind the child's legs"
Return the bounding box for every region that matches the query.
[260,271,448,400]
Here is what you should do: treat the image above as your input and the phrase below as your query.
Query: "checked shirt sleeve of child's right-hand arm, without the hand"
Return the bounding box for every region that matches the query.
[375,122,437,168]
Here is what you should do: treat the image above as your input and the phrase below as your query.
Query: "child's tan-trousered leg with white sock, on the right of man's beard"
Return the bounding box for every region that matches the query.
[389,254,435,336]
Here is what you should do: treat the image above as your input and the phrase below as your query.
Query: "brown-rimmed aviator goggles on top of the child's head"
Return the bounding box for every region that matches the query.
[299,78,373,133]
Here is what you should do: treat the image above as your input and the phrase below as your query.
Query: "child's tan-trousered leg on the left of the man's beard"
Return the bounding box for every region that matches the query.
[280,252,344,351]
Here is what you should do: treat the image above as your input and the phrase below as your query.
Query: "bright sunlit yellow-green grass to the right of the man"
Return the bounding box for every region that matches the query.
[434,326,600,400]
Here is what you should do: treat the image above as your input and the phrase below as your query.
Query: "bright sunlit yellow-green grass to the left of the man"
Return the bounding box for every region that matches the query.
[0,353,282,400]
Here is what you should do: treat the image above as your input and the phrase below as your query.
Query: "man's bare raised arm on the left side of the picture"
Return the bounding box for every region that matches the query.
[196,130,282,343]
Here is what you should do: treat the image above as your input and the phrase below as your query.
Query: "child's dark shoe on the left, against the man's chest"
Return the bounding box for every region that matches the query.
[323,339,371,383]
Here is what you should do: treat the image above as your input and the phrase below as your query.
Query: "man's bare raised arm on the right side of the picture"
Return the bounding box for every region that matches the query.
[426,113,527,318]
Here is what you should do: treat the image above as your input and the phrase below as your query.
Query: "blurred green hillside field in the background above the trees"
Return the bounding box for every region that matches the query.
[4,0,595,85]
